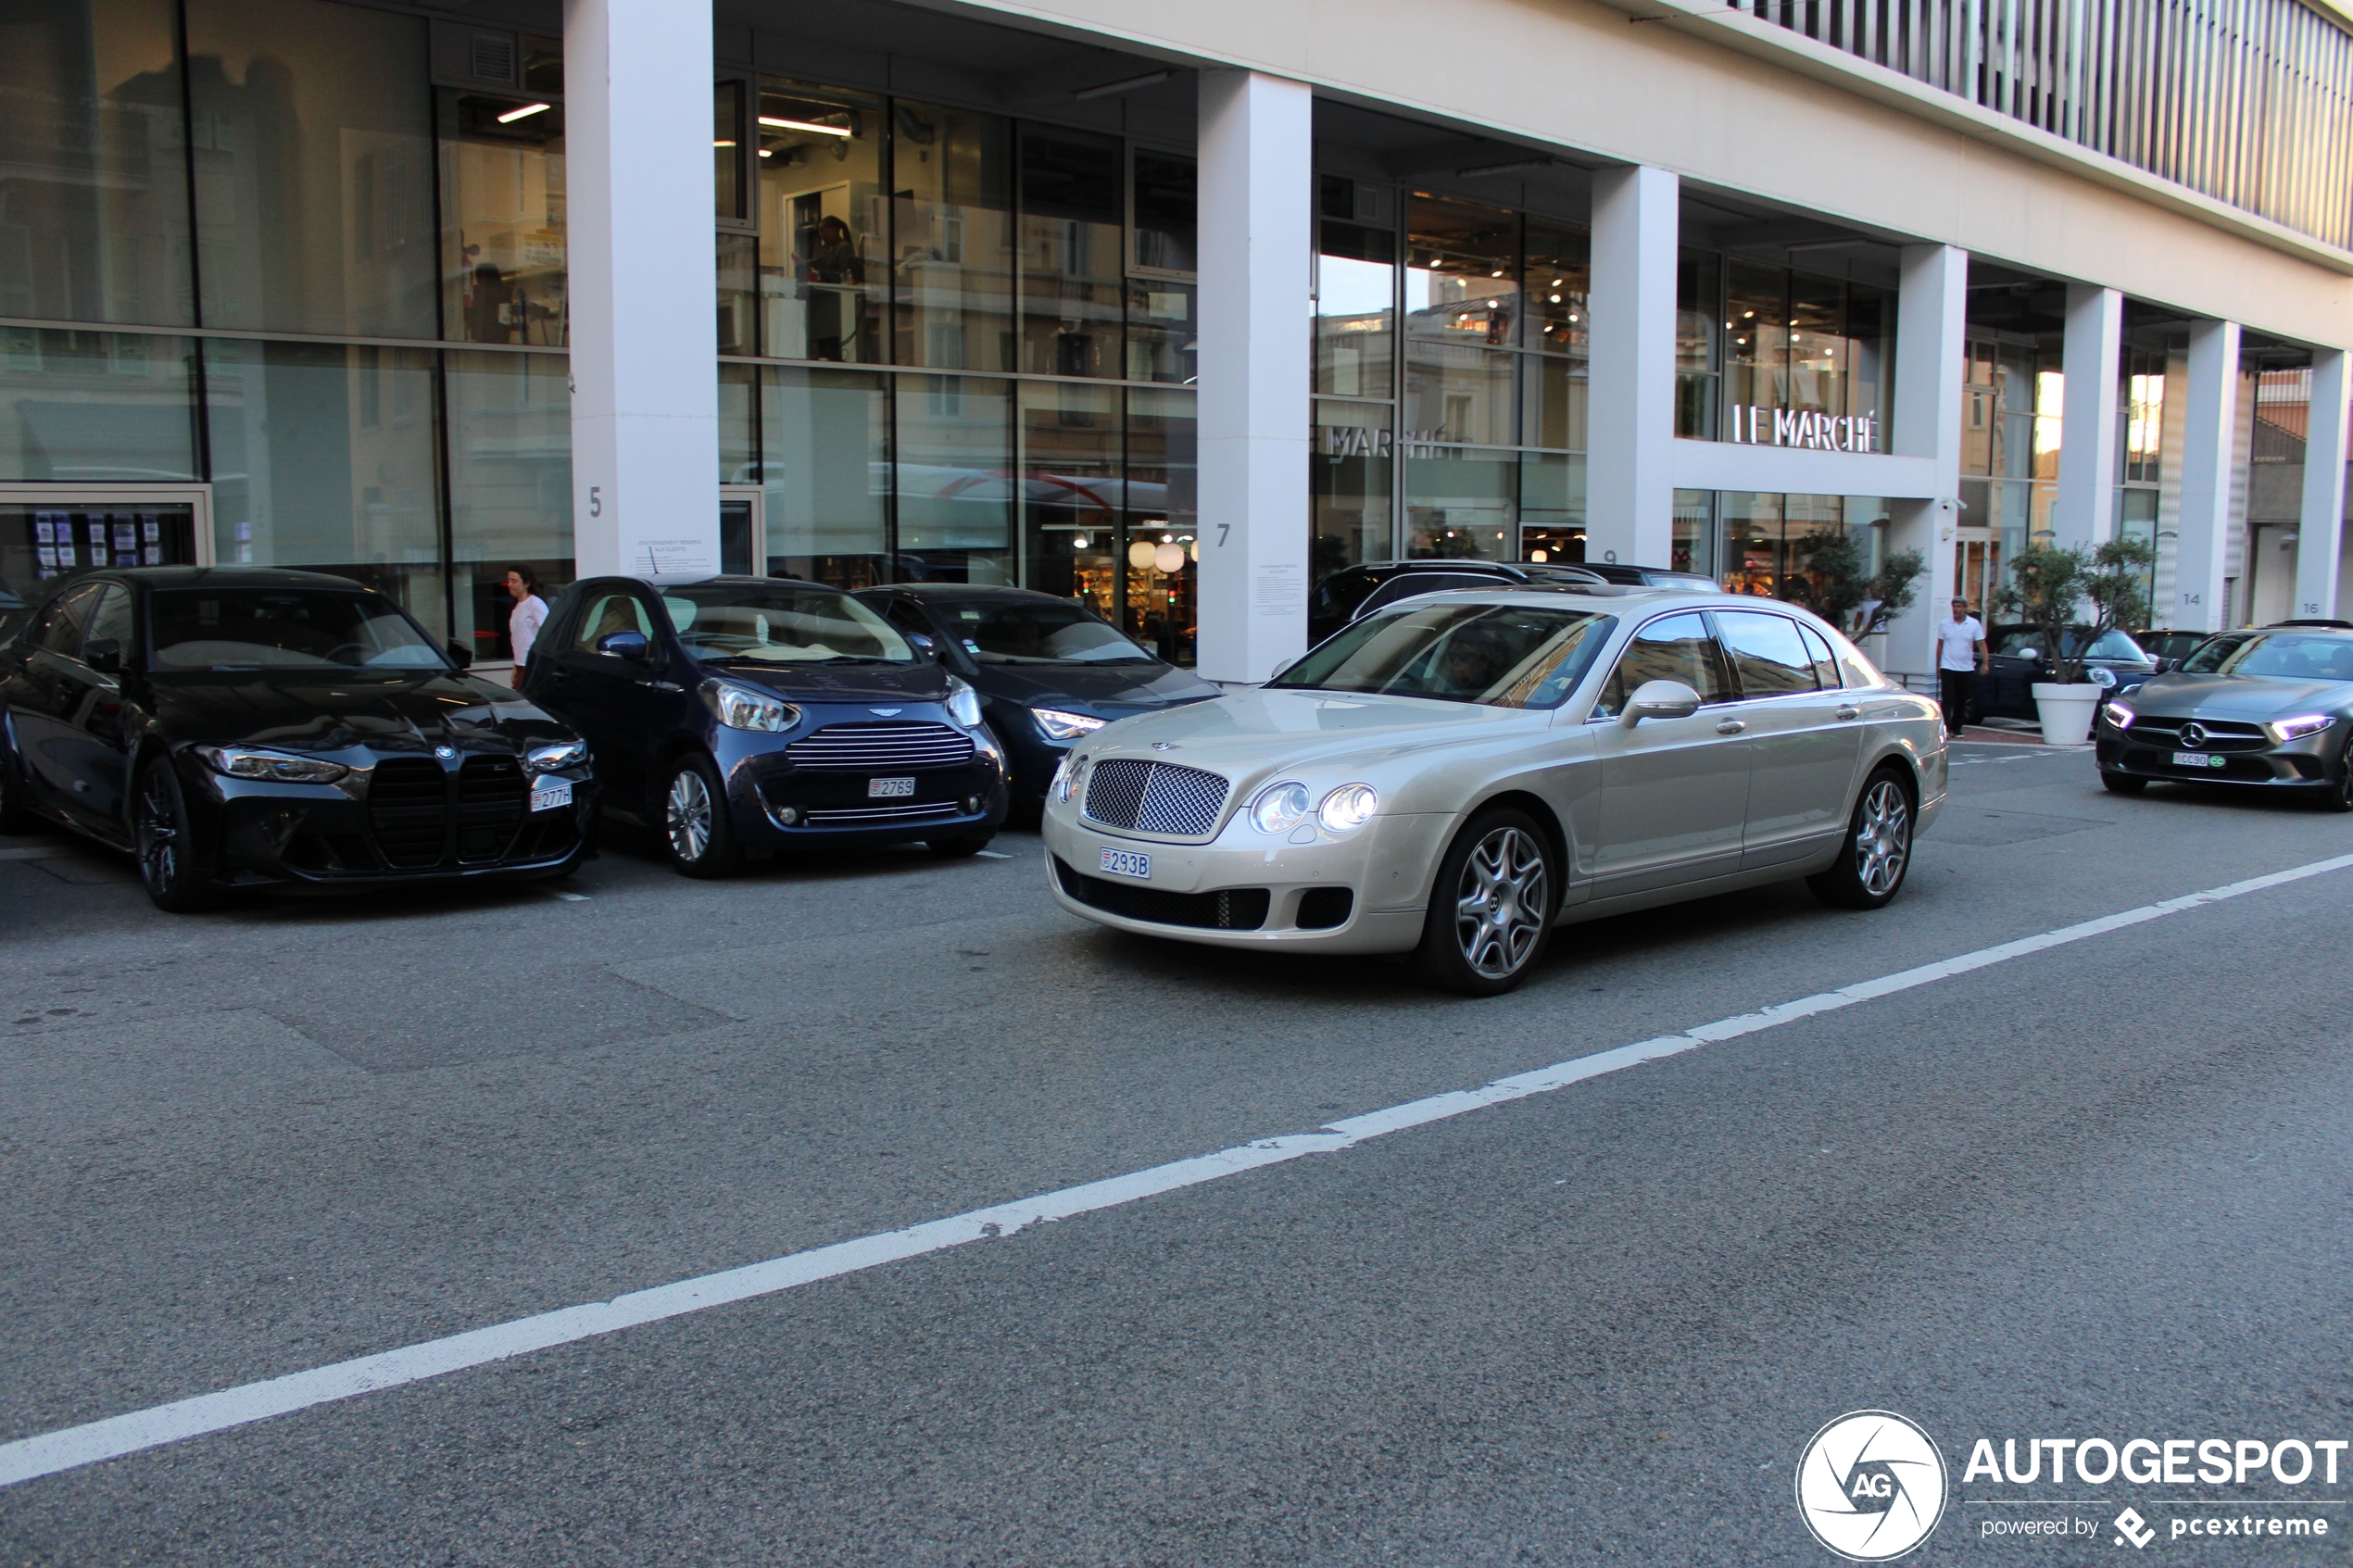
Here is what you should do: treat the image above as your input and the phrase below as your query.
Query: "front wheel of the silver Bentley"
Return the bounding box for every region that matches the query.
[1419,807,1560,997]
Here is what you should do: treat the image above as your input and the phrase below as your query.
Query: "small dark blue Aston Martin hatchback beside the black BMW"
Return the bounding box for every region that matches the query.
[522,576,1007,877]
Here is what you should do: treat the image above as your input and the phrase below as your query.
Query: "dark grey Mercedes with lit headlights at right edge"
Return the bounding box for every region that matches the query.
[2095,628,2353,811]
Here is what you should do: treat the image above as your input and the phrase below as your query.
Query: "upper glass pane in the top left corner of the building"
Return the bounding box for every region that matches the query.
[0,0,195,327]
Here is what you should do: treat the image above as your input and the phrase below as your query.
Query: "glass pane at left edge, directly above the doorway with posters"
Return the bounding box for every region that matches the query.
[0,327,200,484]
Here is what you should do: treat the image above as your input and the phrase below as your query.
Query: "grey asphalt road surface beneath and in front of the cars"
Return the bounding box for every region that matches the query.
[0,746,2353,1568]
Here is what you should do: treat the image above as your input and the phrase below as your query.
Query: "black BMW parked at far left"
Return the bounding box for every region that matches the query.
[0,567,596,909]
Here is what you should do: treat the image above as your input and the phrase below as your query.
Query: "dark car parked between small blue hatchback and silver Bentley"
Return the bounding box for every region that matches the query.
[857,583,1216,813]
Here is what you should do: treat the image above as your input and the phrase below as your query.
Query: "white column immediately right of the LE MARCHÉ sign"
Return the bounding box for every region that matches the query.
[1887,245,1969,677]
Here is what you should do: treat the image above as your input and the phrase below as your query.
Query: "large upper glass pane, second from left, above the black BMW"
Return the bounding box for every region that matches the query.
[188,0,440,339]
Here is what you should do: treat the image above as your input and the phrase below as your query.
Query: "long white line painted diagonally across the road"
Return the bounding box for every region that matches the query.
[0,856,2353,1486]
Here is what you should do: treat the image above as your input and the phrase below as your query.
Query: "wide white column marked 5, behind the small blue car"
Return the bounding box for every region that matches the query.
[565,0,720,578]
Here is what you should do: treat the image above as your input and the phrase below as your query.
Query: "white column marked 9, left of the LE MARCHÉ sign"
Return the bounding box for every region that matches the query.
[1586,167,1708,571]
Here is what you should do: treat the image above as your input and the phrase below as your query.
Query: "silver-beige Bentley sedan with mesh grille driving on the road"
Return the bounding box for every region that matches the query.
[1045,588,1946,997]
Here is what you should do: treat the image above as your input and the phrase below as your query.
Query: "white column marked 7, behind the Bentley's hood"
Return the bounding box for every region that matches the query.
[1198,70,1315,684]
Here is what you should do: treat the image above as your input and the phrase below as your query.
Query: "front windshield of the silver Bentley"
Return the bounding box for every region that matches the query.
[1266,602,1617,708]
